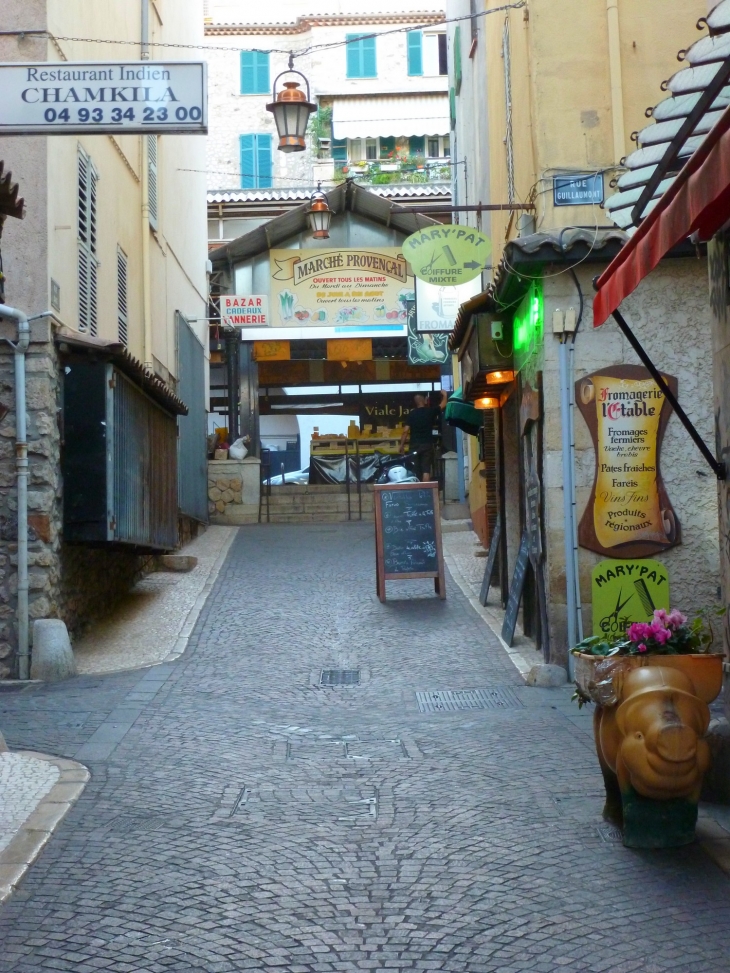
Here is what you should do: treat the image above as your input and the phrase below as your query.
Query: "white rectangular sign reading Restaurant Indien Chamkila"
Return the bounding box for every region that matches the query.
[0,61,208,135]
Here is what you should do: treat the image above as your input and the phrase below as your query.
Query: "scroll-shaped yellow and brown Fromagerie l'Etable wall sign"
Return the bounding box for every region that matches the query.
[575,365,681,558]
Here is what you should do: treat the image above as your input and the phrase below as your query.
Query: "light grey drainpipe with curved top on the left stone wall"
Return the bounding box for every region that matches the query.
[0,304,30,679]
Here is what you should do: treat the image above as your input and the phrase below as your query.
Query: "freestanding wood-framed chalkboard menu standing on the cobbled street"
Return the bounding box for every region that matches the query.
[374,482,446,601]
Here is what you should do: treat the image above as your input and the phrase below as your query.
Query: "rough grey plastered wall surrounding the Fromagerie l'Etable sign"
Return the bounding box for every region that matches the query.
[543,258,716,661]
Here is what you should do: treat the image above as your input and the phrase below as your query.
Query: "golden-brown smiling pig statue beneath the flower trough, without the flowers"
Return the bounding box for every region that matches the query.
[594,657,719,848]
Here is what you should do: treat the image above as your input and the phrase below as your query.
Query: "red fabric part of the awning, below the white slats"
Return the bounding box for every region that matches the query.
[593,102,730,328]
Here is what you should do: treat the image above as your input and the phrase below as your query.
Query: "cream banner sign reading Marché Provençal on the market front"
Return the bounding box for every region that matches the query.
[269,247,415,337]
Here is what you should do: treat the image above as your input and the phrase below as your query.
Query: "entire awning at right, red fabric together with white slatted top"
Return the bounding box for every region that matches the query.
[593,0,730,327]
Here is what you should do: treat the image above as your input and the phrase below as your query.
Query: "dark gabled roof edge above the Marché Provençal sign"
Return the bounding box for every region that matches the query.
[209,179,438,267]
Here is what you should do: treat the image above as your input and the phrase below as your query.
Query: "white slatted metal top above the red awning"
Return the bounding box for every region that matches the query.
[605,0,730,234]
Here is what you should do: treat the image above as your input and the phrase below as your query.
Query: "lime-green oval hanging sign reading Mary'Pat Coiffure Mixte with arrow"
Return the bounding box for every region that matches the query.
[403,223,492,287]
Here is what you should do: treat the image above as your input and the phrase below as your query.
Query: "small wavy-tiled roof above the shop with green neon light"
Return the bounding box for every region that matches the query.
[449,226,628,351]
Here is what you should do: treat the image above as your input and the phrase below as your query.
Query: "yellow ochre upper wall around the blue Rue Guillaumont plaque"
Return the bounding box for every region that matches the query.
[480,0,707,266]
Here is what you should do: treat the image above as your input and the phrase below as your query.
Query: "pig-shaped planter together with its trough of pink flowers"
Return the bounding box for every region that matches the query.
[572,609,723,848]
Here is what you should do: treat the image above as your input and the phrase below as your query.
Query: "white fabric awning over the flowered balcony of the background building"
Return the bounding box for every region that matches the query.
[332,92,451,139]
